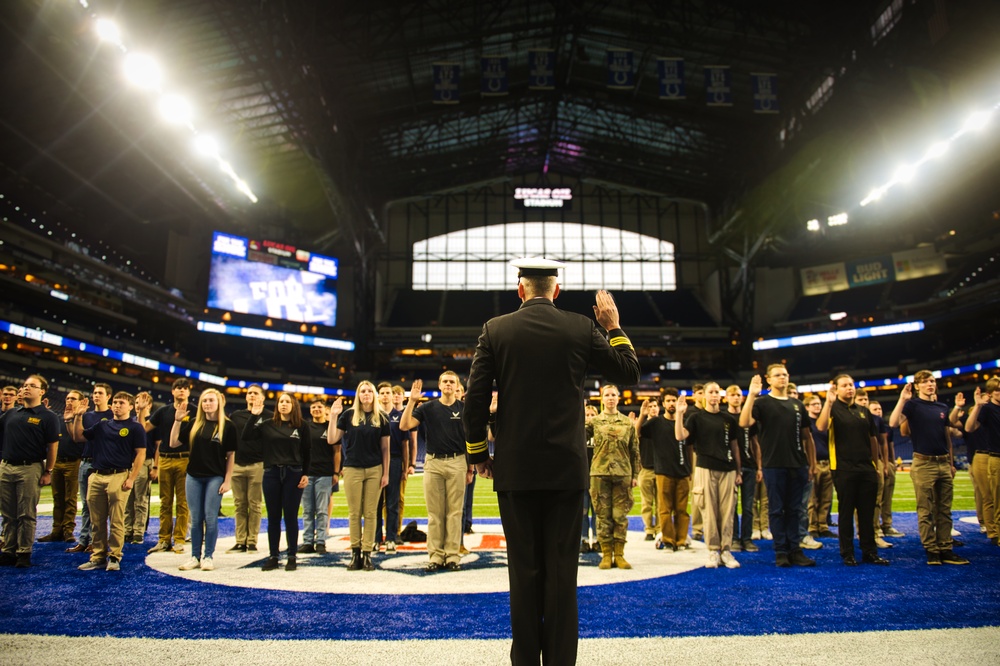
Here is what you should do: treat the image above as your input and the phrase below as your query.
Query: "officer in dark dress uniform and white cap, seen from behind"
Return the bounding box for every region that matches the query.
[463,258,639,665]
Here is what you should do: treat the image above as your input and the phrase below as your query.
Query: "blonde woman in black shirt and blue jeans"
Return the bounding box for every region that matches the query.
[170,389,236,571]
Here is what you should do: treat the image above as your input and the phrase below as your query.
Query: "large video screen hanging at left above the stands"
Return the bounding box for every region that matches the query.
[208,232,338,326]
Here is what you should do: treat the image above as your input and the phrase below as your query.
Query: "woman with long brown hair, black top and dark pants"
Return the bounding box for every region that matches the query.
[243,391,312,571]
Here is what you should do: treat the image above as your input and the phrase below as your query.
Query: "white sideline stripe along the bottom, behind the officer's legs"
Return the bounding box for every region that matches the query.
[0,627,1000,666]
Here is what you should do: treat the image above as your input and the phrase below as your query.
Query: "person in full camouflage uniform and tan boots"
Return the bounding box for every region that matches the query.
[587,384,639,569]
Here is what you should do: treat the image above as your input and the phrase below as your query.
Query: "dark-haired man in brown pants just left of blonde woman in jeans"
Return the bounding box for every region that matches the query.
[145,377,197,554]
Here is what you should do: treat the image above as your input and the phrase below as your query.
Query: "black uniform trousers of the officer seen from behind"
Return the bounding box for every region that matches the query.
[497,490,586,666]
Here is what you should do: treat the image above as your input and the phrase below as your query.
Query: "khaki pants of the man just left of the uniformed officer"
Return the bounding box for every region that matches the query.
[424,453,469,564]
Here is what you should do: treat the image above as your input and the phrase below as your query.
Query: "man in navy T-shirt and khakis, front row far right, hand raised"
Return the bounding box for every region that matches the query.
[892,370,969,566]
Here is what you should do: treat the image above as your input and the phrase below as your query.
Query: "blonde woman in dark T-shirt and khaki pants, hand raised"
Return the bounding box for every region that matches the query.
[327,381,389,571]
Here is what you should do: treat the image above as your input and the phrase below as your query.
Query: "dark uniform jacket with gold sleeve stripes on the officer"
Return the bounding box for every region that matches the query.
[464,298,639,492]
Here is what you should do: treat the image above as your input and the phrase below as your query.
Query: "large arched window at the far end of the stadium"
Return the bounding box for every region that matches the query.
[413,222,677,291]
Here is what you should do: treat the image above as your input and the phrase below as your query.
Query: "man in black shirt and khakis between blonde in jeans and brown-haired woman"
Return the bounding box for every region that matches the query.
[226,384,270,553]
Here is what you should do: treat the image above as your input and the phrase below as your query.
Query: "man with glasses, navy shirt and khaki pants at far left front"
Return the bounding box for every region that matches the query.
[0,375,60,564]
